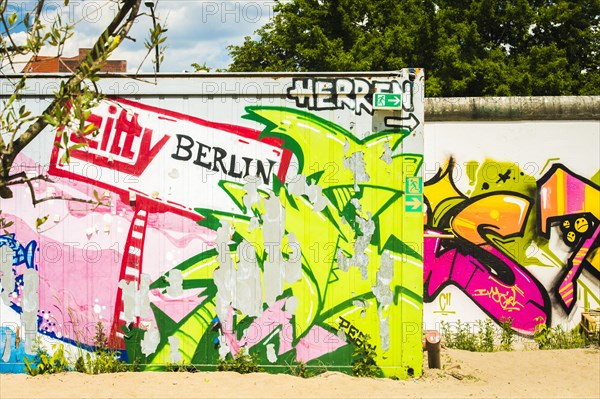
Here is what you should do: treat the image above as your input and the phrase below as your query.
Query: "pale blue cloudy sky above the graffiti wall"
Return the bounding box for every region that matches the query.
[5,0,275,73]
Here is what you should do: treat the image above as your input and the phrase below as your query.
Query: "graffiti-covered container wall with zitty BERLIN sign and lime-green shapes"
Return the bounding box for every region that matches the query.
[0,70,423,377]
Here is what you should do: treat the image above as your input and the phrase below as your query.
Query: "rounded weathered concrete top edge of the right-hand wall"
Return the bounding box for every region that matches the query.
[425,96,600,122]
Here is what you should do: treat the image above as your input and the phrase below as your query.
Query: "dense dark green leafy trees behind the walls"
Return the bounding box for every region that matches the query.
[229,0,600,96]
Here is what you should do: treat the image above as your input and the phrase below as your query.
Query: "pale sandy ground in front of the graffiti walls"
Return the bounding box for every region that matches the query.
[0,349,600,399]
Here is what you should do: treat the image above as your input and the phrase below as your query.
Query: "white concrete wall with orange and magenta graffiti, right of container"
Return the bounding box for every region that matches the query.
[423,118,600,337]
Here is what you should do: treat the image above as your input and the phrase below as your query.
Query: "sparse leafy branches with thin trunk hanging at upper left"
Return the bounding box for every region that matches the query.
[0,0,166,203]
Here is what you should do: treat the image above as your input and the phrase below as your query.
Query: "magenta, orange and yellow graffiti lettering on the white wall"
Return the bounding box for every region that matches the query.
[424,161,600,335]
